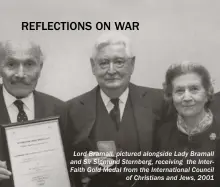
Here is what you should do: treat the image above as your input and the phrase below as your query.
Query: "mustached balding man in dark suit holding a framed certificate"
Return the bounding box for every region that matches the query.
[0,41,64,187]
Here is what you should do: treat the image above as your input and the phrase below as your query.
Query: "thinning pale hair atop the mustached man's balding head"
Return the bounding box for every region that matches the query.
[0,40,44,63]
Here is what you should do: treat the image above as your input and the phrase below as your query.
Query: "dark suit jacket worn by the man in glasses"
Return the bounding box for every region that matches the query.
[63,84,167,186]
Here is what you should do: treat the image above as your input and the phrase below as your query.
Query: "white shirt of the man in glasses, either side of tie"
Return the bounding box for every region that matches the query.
[100,88,129,120]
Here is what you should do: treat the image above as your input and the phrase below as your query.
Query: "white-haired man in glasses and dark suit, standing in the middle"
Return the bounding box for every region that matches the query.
[63,32,167,187]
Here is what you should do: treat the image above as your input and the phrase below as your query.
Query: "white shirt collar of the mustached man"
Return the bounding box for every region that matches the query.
[3,86,34,111]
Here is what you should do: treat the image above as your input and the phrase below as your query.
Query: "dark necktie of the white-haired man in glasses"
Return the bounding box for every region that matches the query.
[110,98,120,130]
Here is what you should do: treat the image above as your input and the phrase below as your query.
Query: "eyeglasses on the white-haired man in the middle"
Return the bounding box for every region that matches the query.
[98,58,132,69]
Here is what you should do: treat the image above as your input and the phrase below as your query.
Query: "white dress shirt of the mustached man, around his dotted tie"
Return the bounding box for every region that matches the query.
[3,86,34,123]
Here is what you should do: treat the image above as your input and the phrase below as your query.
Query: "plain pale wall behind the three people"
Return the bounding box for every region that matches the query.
[0,0,220,100]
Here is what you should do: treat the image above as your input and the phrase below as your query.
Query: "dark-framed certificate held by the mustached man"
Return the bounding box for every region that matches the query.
[1,117,71,187]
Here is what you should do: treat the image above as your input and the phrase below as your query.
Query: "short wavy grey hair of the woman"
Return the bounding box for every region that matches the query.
[163,62,214,107]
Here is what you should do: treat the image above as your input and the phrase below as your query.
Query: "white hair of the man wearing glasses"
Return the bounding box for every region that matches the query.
[92,31,133,59]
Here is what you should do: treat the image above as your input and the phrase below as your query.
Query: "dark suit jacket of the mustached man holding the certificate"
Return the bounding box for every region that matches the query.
[0,85,64,187]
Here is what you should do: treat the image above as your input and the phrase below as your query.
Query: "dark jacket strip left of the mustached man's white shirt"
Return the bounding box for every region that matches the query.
[0,86,11,124]
